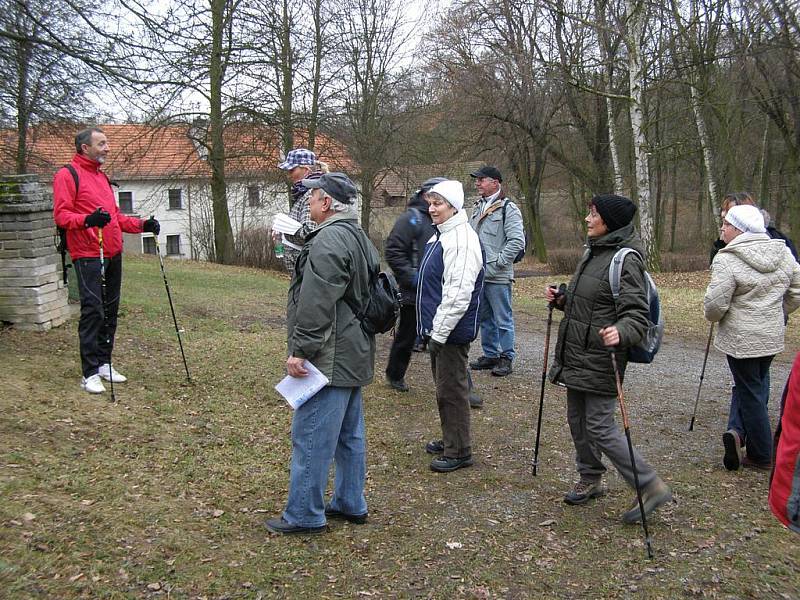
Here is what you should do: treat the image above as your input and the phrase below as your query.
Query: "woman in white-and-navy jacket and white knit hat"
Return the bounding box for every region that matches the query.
[417,181,484,473]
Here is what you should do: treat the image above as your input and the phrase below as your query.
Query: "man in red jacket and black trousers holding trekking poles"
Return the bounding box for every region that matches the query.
[53,127,161,394]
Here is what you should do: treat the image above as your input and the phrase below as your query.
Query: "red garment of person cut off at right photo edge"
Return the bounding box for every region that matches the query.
[769,352,800,533]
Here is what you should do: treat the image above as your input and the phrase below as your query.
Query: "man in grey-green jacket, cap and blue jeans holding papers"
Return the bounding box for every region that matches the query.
[266,173,379,534]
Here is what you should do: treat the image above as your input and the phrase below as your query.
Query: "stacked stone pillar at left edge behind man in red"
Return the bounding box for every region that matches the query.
[0,175,70,331]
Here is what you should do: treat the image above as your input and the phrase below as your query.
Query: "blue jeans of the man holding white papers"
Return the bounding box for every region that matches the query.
[283,386,367,527]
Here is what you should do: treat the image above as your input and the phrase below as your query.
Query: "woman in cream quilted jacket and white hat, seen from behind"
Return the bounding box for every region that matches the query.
[703,205,800,471]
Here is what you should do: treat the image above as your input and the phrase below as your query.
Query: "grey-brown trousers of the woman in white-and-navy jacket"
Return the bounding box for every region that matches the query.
[431,344,472,458]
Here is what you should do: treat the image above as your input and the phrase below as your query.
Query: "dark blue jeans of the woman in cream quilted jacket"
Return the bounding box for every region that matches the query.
[728,356,775,463]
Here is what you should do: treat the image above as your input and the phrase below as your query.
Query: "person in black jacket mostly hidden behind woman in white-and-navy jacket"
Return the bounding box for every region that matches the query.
[385,177,445,392]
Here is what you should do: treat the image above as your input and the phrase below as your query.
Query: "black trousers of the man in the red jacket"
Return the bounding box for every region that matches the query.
[73,254,122,377]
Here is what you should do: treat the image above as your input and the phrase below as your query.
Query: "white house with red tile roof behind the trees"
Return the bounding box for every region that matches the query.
[0,123,355,260]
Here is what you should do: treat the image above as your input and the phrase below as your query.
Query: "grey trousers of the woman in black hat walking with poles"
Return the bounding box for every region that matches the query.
[567,389,658,487]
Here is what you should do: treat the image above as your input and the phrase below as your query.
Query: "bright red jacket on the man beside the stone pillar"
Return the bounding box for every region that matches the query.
[53,154,143,260]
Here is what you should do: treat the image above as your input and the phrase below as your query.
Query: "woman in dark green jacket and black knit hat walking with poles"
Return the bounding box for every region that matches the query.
[545,194,672,523]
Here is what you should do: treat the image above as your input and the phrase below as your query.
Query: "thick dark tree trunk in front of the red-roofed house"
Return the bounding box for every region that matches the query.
[208,0,234,264]
